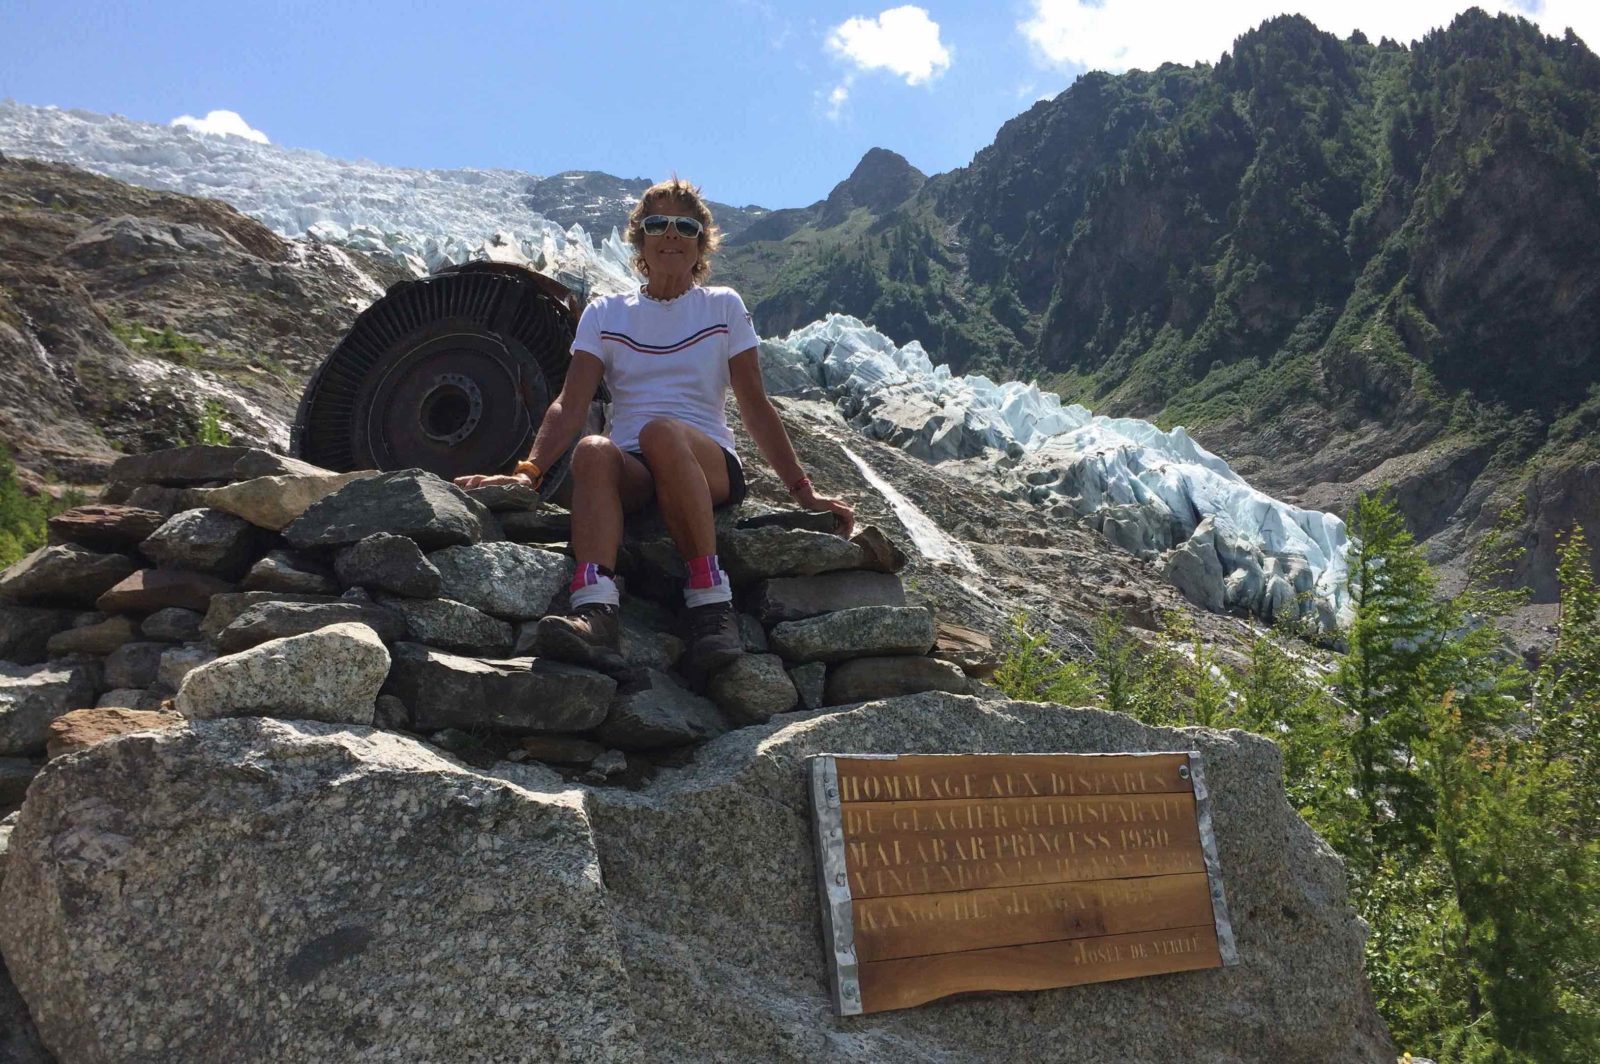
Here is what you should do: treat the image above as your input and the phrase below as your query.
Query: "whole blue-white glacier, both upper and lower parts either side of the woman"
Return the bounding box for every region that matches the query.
[0,101,1350,629]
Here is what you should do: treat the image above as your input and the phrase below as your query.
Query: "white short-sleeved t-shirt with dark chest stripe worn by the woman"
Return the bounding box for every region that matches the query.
[573,285,760,451]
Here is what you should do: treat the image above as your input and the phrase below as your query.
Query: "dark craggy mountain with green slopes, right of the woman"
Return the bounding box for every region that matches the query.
[722,11,1600,600]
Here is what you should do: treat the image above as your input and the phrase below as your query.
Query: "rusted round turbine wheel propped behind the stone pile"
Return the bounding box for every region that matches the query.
[291,262,592,491]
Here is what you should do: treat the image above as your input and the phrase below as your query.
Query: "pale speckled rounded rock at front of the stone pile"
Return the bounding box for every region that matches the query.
[174,624,389,725]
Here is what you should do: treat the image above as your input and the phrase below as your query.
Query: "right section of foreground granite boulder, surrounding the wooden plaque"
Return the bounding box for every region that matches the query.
[590,694,1395,1064]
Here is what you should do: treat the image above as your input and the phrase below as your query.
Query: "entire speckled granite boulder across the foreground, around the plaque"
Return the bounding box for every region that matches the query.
[0,694,1395,1064]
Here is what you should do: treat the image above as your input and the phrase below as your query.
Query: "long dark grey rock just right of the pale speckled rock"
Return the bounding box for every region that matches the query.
[384,643,616,734]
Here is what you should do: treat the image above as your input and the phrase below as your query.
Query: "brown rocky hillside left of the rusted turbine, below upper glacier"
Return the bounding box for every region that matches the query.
[0,157,402,485]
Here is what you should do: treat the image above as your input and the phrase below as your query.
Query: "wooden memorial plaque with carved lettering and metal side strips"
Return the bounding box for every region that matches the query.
[811,752,1237,1016]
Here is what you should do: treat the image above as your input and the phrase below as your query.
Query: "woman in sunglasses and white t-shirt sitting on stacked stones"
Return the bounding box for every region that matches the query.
[456,178,856,682]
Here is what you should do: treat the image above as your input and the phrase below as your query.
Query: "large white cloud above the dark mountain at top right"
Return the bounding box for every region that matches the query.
[1018,0,1600,72]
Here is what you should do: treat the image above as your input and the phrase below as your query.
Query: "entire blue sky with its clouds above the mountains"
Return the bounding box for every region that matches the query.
[0,0,1600,208]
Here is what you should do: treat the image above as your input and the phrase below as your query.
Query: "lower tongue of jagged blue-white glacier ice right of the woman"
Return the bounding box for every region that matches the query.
[762,314,1350,629]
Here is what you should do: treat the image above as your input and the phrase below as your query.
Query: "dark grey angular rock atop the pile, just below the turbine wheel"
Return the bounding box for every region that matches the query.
[283,469,498,550]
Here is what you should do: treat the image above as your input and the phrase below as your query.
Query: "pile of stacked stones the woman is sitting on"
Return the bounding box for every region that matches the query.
[0,446,994,816]
